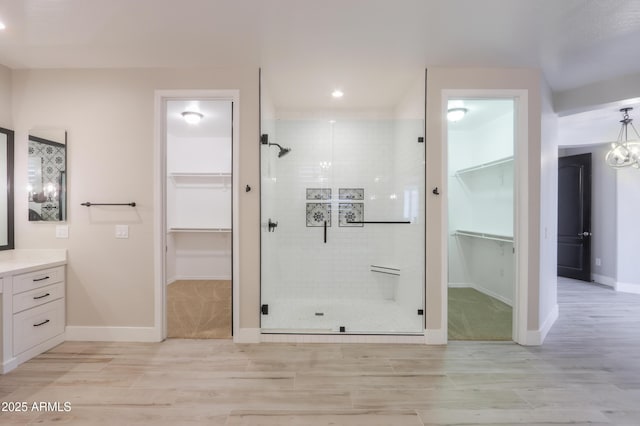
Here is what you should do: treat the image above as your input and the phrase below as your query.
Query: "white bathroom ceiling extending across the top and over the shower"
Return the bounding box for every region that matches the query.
[0,0,640,136]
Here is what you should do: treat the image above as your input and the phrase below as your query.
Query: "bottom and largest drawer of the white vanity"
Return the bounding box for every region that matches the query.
[13,299,65,356]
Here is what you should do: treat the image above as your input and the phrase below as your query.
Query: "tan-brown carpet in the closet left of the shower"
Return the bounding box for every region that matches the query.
[167,280,231,339]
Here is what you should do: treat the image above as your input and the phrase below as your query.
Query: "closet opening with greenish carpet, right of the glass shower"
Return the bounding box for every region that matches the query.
[447,98,516,341]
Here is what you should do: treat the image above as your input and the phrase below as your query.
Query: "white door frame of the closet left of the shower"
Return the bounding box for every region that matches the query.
[153,89,240,342]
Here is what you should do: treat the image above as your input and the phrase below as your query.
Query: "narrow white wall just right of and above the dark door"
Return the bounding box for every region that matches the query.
[559,141,618,286]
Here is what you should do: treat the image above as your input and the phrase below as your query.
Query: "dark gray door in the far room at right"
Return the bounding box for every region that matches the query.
[558,153,591,281]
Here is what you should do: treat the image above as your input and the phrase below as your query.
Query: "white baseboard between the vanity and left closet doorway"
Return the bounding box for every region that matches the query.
[65,325,160,342]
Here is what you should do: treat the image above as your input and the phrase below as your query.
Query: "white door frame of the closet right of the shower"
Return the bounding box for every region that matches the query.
[440,89,529,345]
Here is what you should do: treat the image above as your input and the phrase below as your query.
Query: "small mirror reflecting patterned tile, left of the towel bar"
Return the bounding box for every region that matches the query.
[27,128,67,222]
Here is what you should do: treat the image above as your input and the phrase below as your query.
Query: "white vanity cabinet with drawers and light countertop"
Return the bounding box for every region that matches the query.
[0,250,66,373]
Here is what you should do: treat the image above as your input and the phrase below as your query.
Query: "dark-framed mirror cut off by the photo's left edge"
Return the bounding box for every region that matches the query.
[0,127,15,250]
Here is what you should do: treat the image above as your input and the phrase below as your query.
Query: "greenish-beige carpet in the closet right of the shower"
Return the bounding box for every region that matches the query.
[448,288,512,340]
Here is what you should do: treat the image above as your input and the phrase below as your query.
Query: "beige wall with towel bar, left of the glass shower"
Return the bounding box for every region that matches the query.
[12,66,259,328]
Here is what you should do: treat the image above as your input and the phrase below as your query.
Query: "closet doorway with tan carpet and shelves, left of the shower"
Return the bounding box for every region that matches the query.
[156,91,237,339]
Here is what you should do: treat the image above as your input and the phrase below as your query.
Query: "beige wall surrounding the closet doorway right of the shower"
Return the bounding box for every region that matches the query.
[425,67,544,344]
